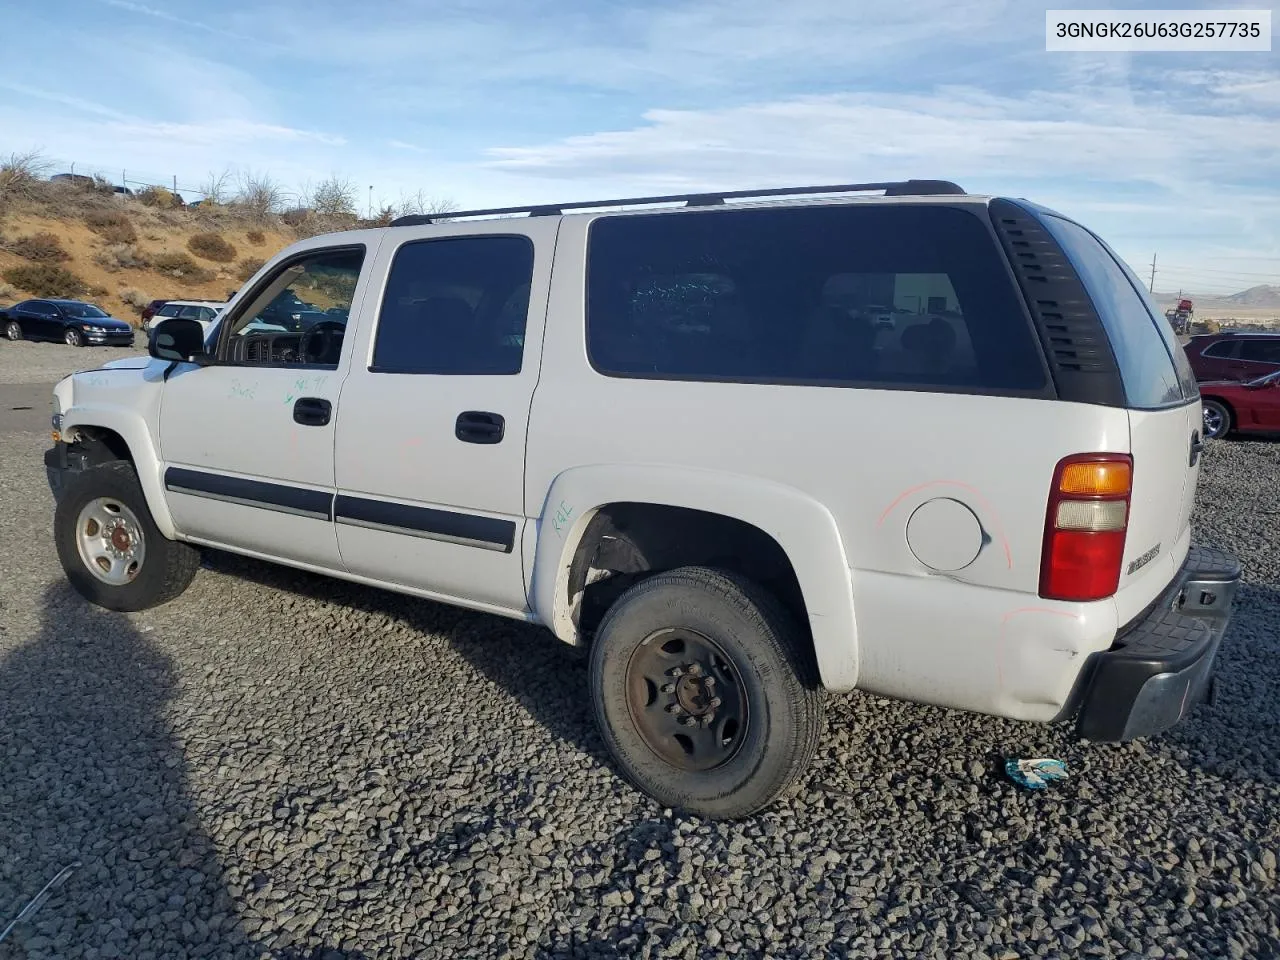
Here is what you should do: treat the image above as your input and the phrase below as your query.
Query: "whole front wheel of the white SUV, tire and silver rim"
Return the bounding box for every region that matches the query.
[54,461,200,612]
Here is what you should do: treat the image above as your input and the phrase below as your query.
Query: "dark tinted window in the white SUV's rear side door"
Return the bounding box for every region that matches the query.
[370,237,534,374]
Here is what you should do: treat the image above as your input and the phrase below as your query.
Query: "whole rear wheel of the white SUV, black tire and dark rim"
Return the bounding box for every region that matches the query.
[590,567,824,819]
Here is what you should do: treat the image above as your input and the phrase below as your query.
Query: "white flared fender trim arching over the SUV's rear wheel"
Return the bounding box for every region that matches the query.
[530,463,858,691]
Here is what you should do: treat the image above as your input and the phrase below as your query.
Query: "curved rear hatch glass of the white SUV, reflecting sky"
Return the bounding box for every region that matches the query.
[1044,216,1194,410]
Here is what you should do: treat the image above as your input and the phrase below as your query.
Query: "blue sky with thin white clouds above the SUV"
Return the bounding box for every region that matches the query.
[0,0,1280,294]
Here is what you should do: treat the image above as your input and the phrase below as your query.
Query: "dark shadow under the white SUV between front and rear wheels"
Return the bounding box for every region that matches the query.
[204,549,611,764]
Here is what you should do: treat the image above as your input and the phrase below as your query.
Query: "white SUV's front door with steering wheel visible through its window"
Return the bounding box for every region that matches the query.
[160,244,372,570]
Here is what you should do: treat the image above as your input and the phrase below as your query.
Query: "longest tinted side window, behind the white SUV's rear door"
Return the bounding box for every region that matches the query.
[588,205,1047,392]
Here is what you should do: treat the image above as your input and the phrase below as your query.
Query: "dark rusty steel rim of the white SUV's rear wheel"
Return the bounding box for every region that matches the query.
[625,627,749,773]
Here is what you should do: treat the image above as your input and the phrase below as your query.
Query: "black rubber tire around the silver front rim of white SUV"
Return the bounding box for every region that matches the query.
[54,460,200,612]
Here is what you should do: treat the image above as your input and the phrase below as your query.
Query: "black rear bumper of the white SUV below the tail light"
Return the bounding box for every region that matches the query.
[1076,547,1240,741]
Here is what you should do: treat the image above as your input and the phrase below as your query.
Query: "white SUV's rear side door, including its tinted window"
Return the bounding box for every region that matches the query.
[334,224,558,613]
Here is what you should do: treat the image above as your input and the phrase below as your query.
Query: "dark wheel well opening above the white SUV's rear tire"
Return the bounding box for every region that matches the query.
[568,503,809,639]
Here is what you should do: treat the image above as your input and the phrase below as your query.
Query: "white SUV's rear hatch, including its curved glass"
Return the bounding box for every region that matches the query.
[1041,214,1203,623]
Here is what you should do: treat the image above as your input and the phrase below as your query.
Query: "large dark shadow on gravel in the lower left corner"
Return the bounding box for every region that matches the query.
[0,582,346,960]
